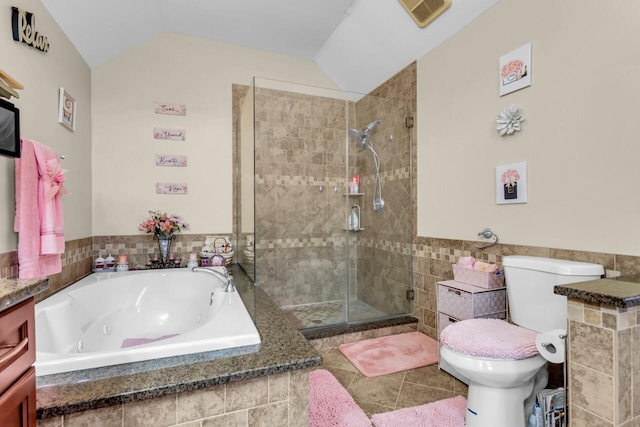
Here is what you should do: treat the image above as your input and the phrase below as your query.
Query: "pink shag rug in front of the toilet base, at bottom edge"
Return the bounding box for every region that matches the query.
[371,396,467,427]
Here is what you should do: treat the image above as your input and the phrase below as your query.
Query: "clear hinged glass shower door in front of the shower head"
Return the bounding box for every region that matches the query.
[347,93,413,323]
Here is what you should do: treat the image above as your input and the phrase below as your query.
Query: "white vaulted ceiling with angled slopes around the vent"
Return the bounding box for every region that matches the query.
[42,0,499,93]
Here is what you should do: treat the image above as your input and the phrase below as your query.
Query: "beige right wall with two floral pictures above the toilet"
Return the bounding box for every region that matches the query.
[418,0,640,255]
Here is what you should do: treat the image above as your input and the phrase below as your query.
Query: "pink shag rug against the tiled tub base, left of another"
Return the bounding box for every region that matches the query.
[309,369,371,427]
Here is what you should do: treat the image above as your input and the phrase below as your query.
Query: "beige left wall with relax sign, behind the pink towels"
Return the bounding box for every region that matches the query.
[0,0,91,253]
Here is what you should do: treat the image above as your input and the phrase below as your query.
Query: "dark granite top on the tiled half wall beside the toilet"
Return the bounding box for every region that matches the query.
[554,274,640,308]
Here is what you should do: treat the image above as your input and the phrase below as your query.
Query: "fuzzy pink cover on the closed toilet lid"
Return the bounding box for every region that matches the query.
[440,319,539,360]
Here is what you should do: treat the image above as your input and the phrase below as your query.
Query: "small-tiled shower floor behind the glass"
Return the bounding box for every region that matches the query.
[281,300,386,329]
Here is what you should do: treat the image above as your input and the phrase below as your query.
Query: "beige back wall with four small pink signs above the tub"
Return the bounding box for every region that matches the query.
[92,33,335,235]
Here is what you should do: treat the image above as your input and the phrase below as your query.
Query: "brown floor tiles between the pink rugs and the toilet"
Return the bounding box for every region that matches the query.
[318,348,467,417]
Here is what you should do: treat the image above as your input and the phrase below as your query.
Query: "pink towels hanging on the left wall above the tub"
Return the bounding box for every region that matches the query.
[14,138,67,279]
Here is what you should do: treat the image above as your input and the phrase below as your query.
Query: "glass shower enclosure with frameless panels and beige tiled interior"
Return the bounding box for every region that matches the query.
[234,78,413,329]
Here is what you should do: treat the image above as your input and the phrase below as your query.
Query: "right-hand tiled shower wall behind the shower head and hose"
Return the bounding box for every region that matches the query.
[350,63,416,314]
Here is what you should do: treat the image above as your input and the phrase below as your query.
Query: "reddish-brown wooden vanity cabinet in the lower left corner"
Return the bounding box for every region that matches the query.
[0,298,36,427]
